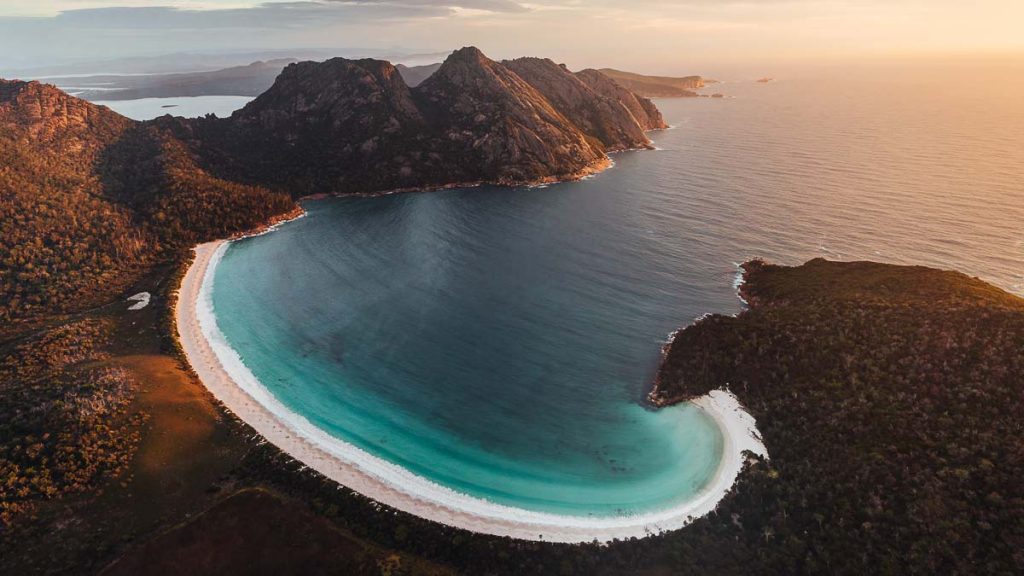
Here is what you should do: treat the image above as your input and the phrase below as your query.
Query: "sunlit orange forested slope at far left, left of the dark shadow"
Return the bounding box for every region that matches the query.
[0,81,146,324]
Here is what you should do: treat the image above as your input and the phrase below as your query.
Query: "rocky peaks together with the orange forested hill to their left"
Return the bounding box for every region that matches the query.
[0,48,666,321]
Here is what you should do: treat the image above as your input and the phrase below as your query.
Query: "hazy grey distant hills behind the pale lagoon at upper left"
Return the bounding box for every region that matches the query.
[53,58,297,100]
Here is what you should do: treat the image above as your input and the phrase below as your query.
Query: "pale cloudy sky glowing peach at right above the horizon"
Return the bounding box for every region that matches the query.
[0,0,1024,74]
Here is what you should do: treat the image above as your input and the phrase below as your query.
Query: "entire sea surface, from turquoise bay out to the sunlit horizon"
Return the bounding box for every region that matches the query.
[207,67,1024,516]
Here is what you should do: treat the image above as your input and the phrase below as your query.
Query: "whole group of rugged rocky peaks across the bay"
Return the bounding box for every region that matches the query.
[182,48,664,197]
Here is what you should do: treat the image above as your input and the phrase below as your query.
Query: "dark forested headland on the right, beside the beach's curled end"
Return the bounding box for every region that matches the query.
[652,259,1024,574]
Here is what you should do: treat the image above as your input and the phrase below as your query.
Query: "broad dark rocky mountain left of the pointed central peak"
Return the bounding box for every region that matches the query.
[190,58,431,196]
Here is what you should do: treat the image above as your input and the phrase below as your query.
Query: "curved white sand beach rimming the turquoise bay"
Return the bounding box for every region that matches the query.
[175,241,767,542]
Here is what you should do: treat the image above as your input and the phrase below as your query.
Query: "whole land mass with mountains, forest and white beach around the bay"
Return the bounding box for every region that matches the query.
[0,43,1024,574]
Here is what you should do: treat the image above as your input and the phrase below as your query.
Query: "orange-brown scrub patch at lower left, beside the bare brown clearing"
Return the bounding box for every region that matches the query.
[0,320,138,532]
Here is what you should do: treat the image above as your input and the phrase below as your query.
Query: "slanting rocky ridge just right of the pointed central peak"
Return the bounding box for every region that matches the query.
[502,57,650,151]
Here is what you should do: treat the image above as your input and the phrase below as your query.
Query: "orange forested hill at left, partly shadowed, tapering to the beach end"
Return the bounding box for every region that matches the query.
[0,80,293,332]
